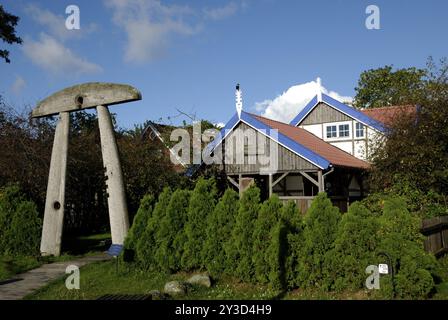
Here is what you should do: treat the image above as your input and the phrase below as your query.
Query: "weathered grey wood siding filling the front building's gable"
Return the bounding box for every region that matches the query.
[224,123,318,174]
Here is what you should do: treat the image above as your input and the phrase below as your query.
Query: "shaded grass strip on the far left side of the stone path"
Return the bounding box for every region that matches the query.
[0,233,110,281]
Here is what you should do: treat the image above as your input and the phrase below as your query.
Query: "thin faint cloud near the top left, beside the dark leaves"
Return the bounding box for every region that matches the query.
[25,4,97,41]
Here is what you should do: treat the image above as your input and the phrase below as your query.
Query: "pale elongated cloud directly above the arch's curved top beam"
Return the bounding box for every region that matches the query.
[22,33,102,75]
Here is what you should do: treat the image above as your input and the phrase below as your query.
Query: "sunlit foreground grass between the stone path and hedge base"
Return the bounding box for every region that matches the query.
[25,261,448,300]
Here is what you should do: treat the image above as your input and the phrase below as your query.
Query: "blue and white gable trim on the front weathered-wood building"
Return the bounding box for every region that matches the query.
[206,111,330,169]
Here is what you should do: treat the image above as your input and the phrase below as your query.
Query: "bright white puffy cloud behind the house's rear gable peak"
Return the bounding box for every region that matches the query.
[255,81,353,123]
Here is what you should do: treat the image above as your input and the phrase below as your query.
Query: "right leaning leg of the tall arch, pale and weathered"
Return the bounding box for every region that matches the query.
[96,106,129,244]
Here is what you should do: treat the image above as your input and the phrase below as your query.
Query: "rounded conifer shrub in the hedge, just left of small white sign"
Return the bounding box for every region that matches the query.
[326,202,380,291]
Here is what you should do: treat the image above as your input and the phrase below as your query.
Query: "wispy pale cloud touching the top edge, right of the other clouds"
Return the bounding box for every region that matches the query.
[105,0,200,63]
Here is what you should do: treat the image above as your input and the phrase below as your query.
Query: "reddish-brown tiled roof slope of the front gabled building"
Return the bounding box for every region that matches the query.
[251,114,370,168]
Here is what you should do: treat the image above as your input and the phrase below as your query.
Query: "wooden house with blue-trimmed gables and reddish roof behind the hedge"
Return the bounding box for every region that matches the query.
[207,87,416,212]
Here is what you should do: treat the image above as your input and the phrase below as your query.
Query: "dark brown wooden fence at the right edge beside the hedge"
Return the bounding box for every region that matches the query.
[421,216,448,257]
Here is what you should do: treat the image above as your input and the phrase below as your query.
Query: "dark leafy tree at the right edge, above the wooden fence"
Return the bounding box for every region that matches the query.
[370,60,448,215]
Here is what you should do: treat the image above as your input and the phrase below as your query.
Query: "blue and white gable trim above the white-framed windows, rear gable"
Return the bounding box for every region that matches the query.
[289,93,385,132]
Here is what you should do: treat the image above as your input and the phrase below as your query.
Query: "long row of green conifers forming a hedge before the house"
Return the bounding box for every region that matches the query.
[126,178,440,299]
